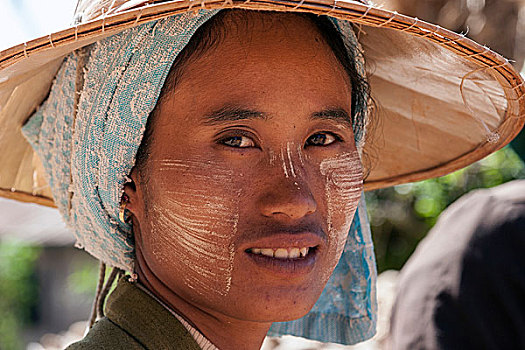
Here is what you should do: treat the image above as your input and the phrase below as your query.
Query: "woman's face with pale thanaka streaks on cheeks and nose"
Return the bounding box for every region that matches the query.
[132,13,363,321]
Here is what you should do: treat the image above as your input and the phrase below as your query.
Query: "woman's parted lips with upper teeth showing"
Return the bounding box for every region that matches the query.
[244,232,324,278]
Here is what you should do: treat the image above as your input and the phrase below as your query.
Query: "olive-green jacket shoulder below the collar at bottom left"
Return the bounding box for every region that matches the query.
[67,317,145,350]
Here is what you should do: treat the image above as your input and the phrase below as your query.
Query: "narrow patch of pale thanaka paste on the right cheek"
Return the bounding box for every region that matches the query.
[319,151,363,273]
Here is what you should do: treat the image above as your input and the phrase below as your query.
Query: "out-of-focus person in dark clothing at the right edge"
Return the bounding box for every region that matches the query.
[388,180,525,350]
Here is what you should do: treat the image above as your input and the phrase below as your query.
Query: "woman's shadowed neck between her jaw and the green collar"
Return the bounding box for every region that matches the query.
[136,249,271,350]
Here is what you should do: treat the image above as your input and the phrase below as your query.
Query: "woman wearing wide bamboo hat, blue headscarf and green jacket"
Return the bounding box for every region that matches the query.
[0,1,523,349]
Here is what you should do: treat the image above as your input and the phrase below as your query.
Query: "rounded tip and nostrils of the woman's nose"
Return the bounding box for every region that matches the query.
[258,178,317,220]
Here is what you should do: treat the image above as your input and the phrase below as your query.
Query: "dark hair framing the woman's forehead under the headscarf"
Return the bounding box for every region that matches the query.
[135,9,370,178]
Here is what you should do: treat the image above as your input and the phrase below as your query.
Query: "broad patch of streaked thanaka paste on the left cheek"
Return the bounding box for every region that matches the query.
[145,160,239,296]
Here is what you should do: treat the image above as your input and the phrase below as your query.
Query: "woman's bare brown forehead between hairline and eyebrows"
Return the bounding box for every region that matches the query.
[156,11,351,133]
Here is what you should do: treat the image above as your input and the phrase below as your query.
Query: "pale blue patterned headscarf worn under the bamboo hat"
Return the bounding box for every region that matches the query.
[23,10,376,344]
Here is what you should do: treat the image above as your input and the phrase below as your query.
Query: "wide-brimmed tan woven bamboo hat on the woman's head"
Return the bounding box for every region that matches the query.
[0,0,525,206]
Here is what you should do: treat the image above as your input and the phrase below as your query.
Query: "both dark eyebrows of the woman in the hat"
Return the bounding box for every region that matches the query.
[203,106,352,127]
